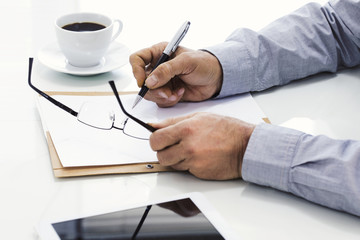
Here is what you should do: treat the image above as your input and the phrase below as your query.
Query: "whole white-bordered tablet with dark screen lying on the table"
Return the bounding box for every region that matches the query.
[36,193,238,240]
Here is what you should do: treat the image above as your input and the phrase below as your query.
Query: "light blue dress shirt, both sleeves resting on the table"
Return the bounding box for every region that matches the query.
[206,0,360,216]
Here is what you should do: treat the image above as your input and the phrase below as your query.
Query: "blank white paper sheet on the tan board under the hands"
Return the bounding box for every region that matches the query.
[38,94,265,167]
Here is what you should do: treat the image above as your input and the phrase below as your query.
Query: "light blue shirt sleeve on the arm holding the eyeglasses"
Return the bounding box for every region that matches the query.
[242,124,360,216]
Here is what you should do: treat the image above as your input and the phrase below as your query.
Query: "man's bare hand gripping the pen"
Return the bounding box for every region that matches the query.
[130,42,222,107]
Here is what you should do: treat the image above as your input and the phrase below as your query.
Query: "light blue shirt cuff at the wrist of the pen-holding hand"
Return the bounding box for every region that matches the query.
[203,41,255,98]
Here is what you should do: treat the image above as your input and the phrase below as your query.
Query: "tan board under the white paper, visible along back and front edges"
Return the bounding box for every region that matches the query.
[41,91,177,178]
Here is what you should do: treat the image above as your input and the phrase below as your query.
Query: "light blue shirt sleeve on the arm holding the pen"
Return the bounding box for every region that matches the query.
[205,0,360,97]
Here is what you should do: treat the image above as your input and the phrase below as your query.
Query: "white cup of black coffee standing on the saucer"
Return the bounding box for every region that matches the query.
[55,12,123,67]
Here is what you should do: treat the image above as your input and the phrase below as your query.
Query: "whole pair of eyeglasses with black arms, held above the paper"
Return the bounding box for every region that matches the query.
[28,58,157,140]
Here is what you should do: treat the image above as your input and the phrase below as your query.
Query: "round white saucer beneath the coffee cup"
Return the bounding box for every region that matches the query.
[38,42,130,76]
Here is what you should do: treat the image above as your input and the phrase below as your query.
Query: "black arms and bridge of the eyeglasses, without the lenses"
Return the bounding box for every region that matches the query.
[28,57,157,132]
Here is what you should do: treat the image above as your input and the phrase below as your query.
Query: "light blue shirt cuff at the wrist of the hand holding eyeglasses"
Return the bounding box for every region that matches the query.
[242,123,304,192]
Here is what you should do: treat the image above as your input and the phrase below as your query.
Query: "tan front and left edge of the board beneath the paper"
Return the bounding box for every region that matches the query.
[46,131,176,178]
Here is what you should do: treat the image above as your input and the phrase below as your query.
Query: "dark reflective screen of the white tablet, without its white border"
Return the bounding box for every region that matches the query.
[52,198,224,240]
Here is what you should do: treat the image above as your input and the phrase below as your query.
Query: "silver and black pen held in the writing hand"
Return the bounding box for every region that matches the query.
[132,21,190,108]
